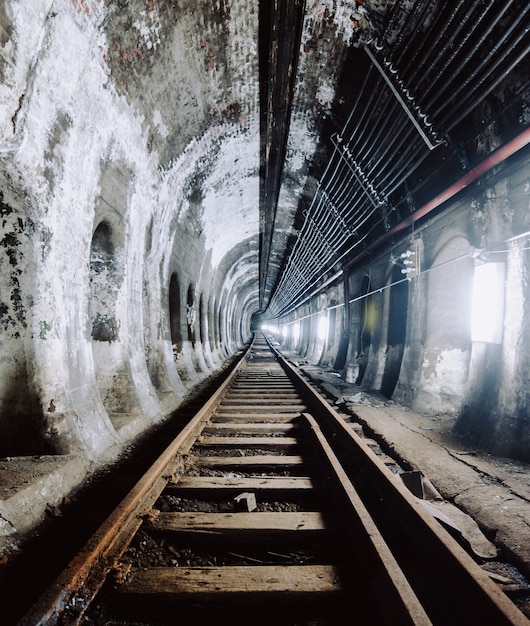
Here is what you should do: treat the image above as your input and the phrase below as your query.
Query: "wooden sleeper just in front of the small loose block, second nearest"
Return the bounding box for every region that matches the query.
[149,511,326,538]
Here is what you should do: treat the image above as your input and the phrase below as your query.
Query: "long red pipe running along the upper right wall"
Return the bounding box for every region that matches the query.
[344,128,530,271]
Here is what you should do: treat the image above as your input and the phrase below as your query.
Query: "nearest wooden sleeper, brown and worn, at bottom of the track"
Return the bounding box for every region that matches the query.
[116,565,342,596]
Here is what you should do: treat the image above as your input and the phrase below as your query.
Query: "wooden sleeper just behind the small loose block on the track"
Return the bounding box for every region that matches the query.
[171,476,318,492]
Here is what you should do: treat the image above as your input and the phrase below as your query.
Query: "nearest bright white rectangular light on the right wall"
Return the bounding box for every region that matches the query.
[471,263,506,343]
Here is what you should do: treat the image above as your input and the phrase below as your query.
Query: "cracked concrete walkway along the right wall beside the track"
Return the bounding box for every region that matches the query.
[285,354,530,592]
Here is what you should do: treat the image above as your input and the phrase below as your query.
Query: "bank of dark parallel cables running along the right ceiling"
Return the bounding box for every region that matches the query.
[269,0,530,316]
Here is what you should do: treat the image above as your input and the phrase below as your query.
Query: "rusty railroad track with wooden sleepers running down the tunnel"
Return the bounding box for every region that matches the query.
[20,333,529,626]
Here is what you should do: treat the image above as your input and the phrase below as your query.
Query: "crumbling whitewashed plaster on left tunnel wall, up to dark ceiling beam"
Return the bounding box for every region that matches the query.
[0,0,272,461]
